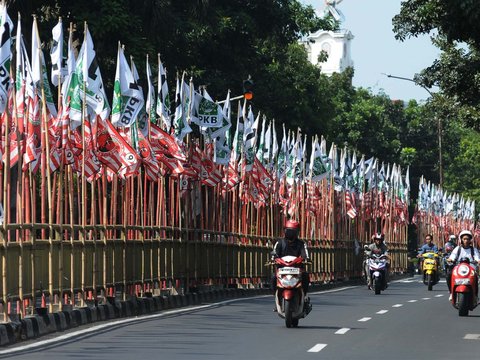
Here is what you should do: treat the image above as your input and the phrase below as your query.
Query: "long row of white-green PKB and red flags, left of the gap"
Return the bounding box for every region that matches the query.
[0,6,474,229]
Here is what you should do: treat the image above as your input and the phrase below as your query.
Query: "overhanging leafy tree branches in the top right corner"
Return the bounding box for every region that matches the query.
[393,0,480,114]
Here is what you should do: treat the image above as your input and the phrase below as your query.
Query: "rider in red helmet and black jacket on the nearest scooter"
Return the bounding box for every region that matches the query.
[272,220,310,310]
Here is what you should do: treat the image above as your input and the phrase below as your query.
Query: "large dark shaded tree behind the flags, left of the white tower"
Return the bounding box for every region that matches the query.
[9,0,335,130]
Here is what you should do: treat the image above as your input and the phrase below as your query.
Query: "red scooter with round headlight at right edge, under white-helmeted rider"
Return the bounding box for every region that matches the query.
[451,258,478,316]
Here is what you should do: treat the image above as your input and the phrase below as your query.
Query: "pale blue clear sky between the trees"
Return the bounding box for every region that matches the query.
[300,0,439,101]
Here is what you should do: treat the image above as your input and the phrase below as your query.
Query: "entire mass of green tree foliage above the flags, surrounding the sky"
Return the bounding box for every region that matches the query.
[7,0,480,210]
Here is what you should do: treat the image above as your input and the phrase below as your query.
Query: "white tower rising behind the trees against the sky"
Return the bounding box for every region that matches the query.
[304,0,353,75]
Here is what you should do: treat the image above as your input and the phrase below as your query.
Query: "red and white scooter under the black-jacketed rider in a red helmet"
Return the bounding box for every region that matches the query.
[267,256,312,328]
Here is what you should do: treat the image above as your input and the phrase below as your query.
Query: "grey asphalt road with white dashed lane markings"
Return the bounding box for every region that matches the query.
[0,275,480,360]
